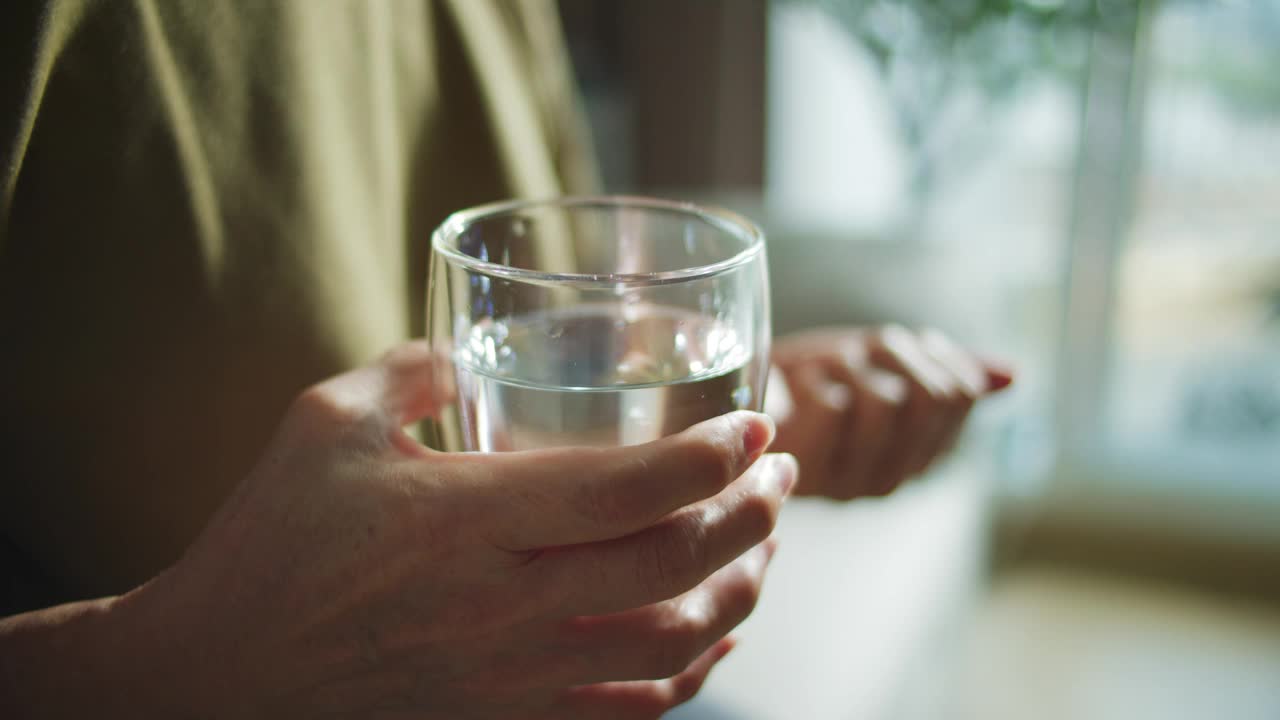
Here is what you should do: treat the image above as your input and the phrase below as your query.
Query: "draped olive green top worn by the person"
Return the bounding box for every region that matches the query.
[0,0,593,611]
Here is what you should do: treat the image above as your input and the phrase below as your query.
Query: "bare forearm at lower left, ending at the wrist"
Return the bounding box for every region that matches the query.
[0,597,177,717]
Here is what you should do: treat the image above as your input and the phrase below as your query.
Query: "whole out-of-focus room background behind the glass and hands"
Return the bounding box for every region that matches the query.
[559,0,1280,720]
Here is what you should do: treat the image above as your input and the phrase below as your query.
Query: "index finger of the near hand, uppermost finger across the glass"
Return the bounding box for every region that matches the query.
[474,411,774,551]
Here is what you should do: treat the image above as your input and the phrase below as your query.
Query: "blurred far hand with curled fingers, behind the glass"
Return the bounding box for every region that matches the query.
[768,325,1012,500]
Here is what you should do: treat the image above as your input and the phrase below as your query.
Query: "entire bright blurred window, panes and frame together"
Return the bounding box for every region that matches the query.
[767,0,1280,532]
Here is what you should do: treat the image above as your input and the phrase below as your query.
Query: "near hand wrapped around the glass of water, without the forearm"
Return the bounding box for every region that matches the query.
[118,345,796,720]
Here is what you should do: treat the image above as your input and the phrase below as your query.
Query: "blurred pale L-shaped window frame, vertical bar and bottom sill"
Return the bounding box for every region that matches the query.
[1037,0,1280,542]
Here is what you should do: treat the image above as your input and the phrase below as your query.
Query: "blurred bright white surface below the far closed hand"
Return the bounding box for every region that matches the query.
[668,462,984,720]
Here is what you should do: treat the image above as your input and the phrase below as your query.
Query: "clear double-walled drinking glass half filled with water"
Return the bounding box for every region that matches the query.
[426,197,769,452]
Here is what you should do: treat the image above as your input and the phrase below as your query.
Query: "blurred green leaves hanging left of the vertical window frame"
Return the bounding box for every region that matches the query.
[778,0,1143,204]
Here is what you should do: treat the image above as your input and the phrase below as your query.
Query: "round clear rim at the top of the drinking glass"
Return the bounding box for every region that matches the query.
[431,195,764,288]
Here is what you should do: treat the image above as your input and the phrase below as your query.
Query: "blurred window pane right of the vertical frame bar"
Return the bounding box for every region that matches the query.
[1098,1,1280,497]
